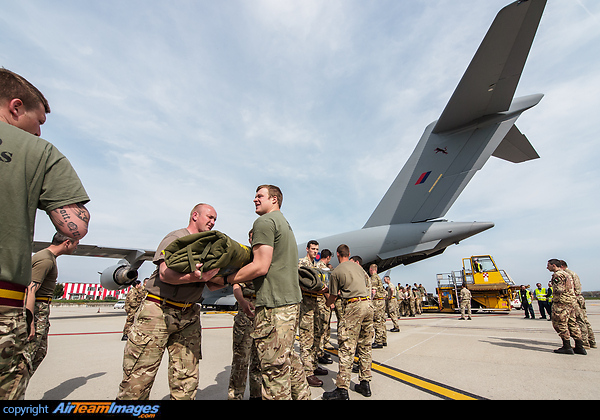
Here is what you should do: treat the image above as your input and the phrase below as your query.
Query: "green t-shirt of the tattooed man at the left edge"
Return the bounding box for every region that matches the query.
[0,122,90,286]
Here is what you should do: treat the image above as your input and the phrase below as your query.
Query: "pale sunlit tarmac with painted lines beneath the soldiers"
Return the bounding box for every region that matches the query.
[25,300,600,401]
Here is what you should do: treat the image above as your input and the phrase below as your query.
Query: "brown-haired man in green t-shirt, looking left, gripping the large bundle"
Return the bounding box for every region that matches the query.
[223,185,311,400]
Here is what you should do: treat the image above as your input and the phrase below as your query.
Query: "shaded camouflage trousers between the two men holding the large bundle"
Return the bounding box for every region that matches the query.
[227,304,262,400]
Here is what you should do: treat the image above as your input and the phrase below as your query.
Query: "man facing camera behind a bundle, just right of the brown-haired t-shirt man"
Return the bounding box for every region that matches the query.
[298,240,327,386]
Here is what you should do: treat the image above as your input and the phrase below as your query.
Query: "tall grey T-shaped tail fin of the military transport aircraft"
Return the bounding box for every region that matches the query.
[363,0,546,228]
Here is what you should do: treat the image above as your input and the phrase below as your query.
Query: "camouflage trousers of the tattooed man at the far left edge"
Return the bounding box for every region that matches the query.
[0,306,29,400]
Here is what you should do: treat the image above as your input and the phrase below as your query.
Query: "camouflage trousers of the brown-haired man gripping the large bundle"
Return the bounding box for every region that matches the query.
[252,304,311,400]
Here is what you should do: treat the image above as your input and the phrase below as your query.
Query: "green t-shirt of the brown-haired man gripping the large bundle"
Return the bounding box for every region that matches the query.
[252,211,302,308]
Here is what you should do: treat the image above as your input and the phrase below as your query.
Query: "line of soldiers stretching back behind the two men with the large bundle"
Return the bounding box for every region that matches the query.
[228,240,416,400]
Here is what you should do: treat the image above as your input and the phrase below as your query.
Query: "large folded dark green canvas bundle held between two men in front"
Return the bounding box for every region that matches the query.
[162,230,252,276]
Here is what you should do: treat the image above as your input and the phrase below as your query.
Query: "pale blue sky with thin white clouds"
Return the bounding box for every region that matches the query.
[0,0,600,292]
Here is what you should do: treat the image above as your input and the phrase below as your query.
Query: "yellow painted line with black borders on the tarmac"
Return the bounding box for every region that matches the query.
[325,349,487,400]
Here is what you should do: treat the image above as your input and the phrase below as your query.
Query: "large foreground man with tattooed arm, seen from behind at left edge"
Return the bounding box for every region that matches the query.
[0,68,90,400]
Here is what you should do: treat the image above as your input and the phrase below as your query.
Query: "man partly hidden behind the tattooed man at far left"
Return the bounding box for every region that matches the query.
[25,232,79,376]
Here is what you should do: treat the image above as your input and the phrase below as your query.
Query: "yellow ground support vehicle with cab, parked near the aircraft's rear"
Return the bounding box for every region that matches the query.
[437,255,518,312]
